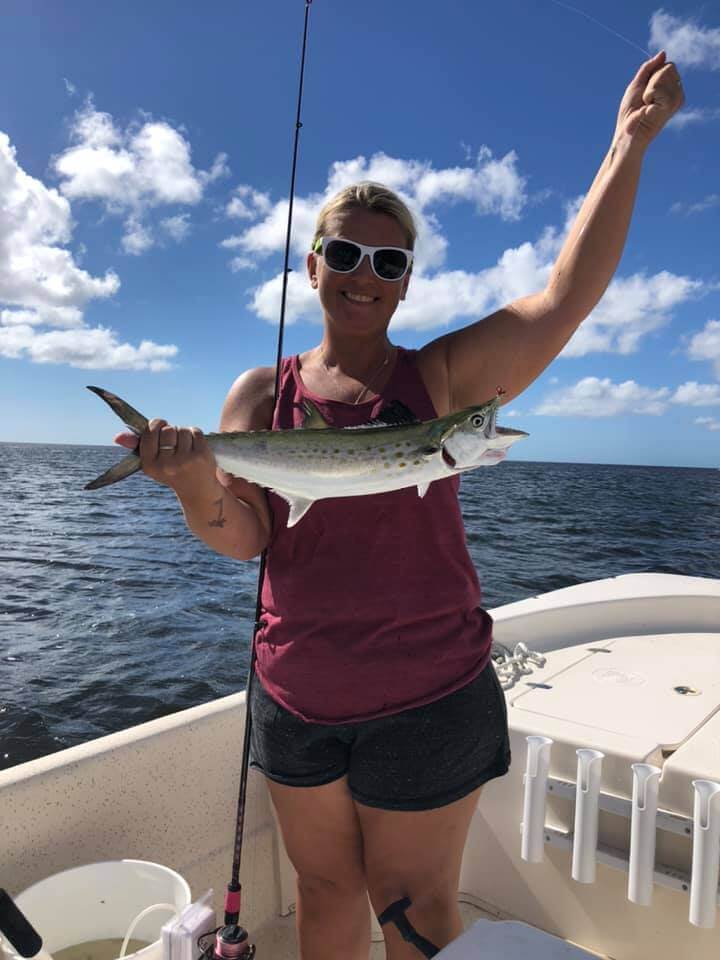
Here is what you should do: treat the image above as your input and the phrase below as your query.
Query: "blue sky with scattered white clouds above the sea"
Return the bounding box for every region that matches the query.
[0,0,720,467]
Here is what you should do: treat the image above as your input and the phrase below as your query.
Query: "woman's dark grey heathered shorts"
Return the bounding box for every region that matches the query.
[250,663,510,810]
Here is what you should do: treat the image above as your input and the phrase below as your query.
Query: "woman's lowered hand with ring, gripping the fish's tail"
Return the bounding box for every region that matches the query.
[114,418,215,496]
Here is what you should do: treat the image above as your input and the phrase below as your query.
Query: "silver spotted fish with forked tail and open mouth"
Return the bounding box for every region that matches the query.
[85,387,527,527]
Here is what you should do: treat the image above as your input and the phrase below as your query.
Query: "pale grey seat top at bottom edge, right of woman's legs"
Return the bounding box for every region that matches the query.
[437,920,598,960]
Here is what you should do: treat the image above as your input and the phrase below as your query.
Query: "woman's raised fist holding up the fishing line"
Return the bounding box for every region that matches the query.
[615,50,685,145]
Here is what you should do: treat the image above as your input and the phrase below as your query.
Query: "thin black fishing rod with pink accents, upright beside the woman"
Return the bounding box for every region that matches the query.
[215,0,312,944]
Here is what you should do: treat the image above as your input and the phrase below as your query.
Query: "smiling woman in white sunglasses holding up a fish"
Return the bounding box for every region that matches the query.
[117,53,683,960]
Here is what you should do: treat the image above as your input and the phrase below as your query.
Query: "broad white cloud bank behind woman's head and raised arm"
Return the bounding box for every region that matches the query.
[236,148,703,342]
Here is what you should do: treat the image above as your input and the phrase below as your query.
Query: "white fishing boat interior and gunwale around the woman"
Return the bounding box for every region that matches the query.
[0,574,720,960]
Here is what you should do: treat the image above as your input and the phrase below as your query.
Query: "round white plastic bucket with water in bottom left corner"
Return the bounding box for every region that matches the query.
[10,860,191,960]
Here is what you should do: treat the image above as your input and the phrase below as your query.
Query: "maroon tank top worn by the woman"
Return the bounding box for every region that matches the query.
[256,349,492,724]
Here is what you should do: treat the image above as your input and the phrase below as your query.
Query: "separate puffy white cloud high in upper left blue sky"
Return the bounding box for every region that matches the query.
[54,98,229,254]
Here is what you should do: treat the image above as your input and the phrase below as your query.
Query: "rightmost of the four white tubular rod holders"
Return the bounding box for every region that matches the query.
[689,780,720,927]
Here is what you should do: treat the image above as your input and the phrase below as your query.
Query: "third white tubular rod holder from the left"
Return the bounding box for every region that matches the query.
[628,763,662,907]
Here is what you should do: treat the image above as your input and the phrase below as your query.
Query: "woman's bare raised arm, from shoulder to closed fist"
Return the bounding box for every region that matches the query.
[419,52,684,410]
